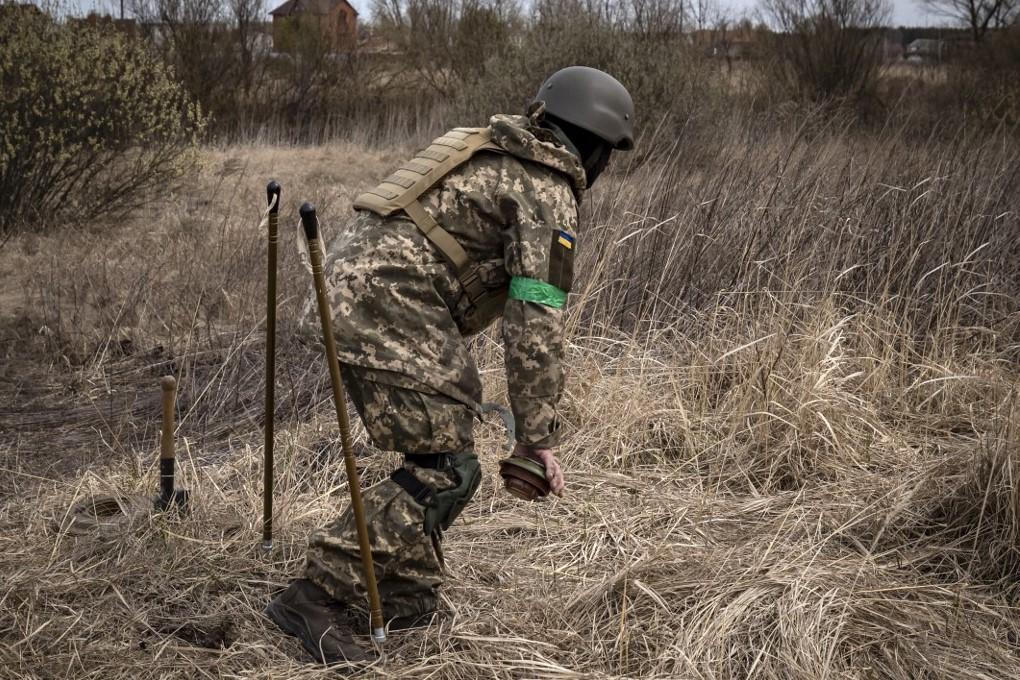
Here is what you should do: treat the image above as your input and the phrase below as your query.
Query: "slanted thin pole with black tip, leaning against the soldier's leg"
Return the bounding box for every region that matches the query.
[300,203,386,643]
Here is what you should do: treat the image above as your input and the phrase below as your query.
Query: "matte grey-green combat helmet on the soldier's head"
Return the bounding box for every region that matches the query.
[534,66,634,151]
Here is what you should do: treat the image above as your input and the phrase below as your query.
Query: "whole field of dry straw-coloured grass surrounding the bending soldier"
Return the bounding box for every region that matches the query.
[0,123,1020,680]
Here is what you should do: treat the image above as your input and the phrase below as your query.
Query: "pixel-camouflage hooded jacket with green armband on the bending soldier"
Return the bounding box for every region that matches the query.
[326,115,585,446]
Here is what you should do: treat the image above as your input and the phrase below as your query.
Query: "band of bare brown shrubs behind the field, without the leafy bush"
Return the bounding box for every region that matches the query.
[35,0,1020,138]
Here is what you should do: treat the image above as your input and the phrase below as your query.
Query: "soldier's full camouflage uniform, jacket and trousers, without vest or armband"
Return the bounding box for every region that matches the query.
[306,115,585,618]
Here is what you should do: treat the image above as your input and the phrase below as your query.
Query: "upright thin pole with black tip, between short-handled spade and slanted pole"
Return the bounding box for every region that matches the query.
[262,180,279,552]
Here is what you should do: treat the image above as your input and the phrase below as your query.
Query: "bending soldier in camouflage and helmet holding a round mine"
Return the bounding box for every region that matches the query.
[266,66,633,664]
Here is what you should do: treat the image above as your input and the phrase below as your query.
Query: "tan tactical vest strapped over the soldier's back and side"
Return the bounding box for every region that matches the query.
[354,127,507,330]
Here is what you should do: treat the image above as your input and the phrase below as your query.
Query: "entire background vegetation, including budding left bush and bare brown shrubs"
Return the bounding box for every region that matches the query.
[0,0,1020,230]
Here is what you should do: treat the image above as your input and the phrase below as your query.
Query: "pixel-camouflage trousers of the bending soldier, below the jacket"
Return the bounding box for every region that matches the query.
[305,366,474,620]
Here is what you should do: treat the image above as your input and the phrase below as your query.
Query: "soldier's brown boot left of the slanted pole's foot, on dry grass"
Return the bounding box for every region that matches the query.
[265,578,374,666]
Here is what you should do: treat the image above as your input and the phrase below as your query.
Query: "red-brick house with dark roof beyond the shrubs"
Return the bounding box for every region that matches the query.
[269,0,358,52]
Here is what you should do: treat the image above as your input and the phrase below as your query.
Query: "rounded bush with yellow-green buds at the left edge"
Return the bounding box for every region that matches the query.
[0,9,205,231]
